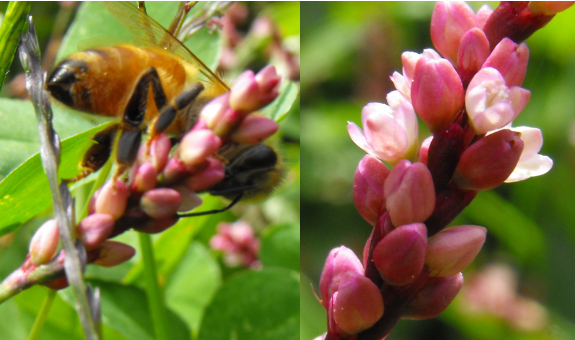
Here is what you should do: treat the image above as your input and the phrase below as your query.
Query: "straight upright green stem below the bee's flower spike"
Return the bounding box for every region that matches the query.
[138,233,169,340]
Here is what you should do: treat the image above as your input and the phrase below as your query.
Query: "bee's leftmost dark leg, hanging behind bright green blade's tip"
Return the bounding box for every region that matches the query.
[64,124,118,183]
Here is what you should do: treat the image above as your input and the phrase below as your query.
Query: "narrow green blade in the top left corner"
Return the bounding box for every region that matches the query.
[0,1,31,88]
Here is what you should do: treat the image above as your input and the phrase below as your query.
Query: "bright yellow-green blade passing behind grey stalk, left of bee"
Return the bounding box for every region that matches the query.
[0,124,115,235]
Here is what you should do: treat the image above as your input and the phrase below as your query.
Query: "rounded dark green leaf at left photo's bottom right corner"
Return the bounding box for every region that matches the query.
[198,268,300,340]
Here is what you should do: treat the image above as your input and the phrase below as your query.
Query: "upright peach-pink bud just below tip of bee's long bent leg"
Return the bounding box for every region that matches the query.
[95,180,130,220]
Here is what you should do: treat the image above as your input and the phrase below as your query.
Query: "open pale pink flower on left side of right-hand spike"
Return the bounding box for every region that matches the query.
[347,98,418,164]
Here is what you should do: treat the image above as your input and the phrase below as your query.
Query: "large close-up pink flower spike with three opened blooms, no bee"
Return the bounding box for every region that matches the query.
[320,2,568,340]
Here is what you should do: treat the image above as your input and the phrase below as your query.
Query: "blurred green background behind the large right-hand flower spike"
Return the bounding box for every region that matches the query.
[301,2,575,340]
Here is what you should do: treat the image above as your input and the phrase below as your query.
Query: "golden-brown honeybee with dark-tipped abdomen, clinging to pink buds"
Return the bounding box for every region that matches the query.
[46,2,283,216]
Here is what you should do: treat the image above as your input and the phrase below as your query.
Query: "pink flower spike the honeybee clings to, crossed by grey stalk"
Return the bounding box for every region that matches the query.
[0,66,281,298]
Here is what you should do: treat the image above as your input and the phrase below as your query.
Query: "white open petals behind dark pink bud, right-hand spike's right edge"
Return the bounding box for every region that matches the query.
[505,126,553,183]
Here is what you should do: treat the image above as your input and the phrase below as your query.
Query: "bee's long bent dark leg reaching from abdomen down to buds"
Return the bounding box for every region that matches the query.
[114,67,167,178]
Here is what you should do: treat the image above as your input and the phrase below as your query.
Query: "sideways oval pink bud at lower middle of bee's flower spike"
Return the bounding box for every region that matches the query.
[140,188,182,219]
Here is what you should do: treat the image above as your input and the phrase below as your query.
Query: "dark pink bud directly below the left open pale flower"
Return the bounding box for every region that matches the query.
[353,155,389,225]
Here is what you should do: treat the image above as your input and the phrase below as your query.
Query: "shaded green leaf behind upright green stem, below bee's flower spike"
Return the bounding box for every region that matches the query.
[60,280,191,340]
